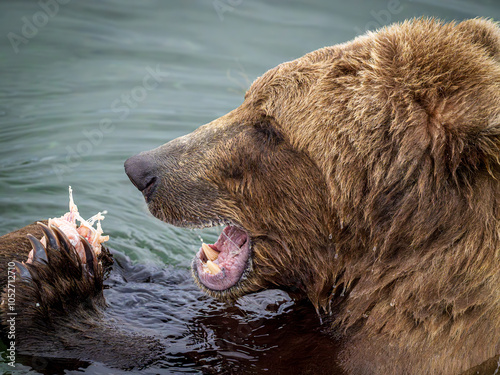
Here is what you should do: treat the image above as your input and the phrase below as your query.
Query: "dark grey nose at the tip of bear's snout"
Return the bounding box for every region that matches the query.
[125,154,158,197]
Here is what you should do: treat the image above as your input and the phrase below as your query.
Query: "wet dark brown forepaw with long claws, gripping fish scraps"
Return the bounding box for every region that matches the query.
[0,221,164,369]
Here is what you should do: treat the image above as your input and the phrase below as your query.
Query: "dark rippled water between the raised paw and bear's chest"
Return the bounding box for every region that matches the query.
[8,253,341,374]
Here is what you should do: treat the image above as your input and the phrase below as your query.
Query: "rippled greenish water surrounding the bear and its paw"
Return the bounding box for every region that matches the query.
[0,0,500,374]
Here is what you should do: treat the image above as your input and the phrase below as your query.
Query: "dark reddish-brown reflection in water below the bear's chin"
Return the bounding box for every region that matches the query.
[184,302,340,374]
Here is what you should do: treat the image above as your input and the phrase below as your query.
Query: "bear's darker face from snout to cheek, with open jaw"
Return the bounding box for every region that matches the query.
[126,101,331,298]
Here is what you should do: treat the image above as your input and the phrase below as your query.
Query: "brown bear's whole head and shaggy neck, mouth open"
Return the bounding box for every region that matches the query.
[125,19,500,374]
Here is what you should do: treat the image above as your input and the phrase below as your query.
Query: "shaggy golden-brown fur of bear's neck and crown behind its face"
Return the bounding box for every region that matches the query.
[247,19,500,374]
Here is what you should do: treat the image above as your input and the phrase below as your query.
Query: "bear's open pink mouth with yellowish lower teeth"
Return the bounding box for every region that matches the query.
[192,225,251,292]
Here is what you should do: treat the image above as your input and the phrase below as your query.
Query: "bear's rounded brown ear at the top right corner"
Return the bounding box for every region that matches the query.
[457,18,500,61]
